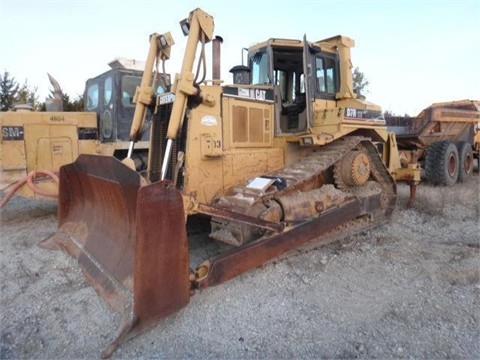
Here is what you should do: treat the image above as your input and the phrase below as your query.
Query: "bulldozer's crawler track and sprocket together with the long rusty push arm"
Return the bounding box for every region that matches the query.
[193,137,396,288]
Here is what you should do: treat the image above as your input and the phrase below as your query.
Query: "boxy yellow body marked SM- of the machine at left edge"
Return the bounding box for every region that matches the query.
[0,111,97,203]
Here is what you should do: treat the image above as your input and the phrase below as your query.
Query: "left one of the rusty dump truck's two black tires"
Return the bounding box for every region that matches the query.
[425,140,460,186]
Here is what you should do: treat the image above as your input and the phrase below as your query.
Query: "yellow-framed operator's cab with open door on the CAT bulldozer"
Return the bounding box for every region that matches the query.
[244,39,340,136]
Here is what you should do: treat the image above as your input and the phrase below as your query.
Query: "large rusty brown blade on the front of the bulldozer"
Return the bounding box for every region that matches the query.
[41,155,190,357]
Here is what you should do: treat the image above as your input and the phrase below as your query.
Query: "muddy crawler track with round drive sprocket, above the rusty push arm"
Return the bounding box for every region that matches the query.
[211,137,395,246]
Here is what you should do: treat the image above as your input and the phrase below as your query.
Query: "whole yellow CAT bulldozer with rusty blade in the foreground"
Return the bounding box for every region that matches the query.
[42,9,396,357]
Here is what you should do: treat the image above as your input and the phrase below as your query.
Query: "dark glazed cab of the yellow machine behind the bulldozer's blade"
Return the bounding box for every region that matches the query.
[84,68,168,143]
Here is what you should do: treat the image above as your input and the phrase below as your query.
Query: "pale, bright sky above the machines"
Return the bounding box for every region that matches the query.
[0,0,480,115]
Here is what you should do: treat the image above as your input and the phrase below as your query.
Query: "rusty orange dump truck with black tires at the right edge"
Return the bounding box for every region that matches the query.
[386,100,480,186]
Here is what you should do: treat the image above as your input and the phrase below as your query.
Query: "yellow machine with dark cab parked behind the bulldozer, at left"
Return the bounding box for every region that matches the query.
[0,33,173,207]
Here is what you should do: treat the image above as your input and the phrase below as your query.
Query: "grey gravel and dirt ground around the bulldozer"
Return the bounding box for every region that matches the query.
[0,173,480,359]
